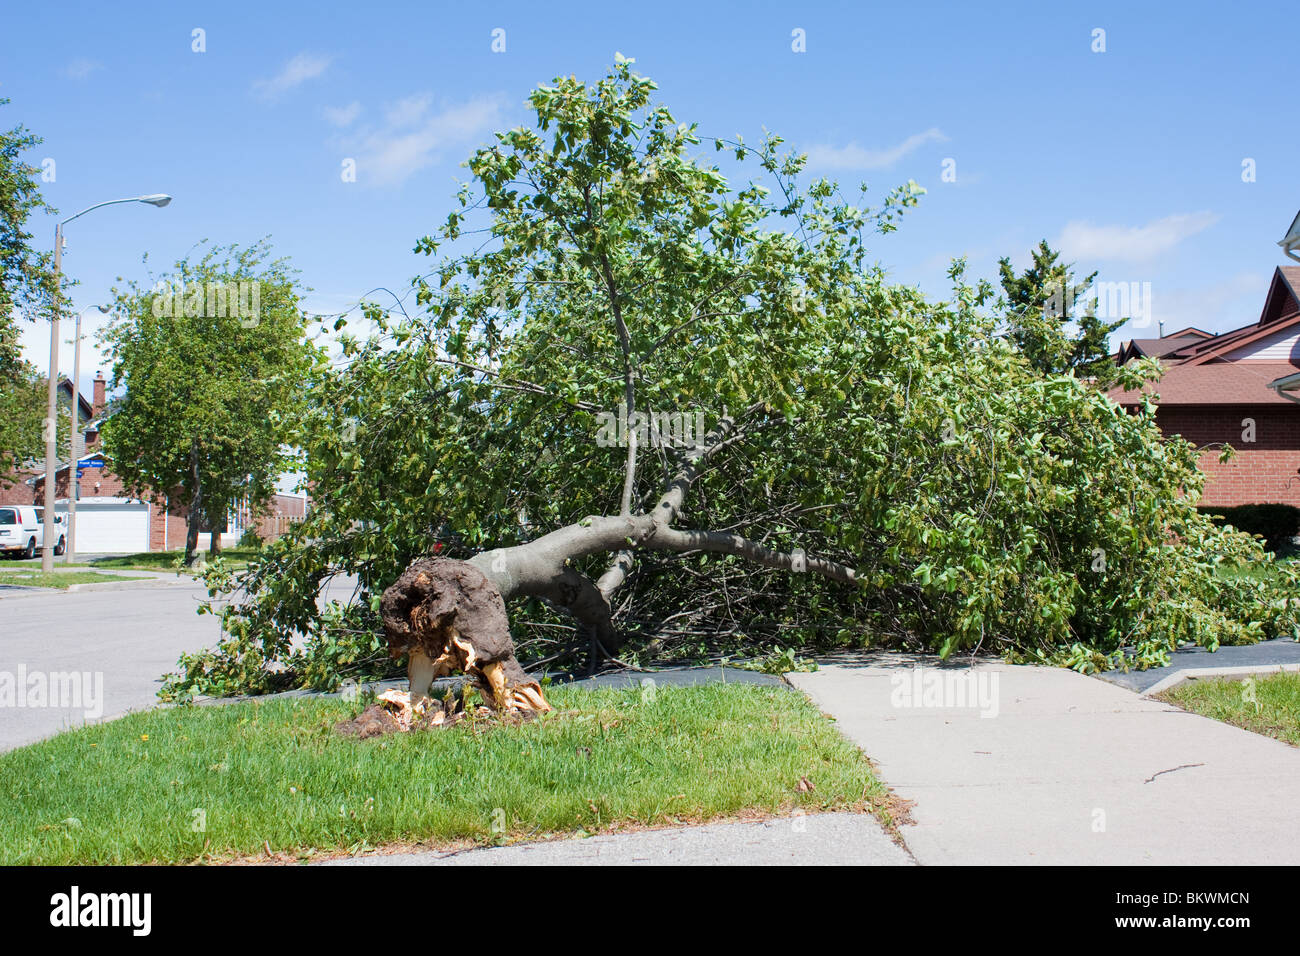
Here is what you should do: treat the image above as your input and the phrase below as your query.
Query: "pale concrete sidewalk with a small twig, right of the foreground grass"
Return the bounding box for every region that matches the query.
[789,654,1300,865]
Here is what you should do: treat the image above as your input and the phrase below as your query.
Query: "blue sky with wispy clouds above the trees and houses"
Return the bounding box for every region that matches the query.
[0,0,1300,390]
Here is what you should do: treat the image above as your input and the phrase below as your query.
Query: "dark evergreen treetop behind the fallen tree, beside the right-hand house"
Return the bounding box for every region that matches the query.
[998,239,1127,384]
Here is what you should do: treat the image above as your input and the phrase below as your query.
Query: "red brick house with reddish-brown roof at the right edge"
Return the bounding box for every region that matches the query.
[1110,265,1300,506]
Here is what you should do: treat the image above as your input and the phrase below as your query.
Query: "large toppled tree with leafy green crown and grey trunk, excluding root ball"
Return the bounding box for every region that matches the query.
[164,61,1295,700]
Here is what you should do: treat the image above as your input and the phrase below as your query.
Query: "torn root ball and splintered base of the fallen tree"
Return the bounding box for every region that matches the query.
[380,558,551,711]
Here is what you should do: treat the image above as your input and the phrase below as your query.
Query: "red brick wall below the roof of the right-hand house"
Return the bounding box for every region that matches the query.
[1156,405,1300,506]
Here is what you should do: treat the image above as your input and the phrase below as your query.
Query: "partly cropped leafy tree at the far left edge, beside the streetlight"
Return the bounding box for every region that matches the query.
[0,99,55,476]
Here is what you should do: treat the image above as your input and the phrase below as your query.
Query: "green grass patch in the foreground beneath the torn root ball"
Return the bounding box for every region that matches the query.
[0,684,891,865]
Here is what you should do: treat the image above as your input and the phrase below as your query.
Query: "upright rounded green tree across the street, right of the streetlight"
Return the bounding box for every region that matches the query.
[103,241,320,564]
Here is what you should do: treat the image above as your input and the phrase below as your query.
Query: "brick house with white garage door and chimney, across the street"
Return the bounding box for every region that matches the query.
[0,375,308,554]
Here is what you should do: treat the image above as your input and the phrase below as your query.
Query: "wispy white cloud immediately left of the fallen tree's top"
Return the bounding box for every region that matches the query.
[343,94,506,185]
